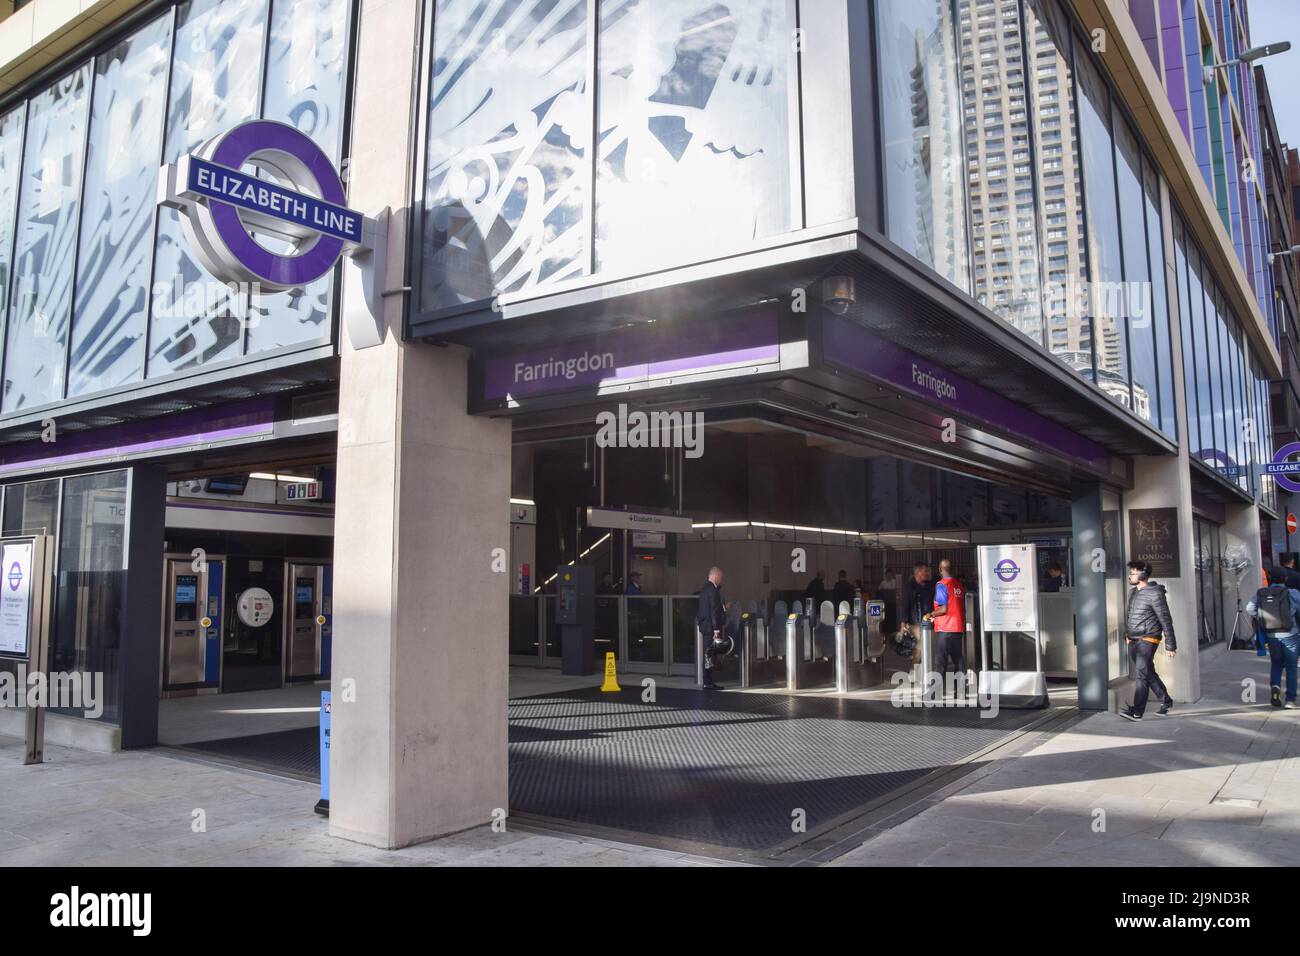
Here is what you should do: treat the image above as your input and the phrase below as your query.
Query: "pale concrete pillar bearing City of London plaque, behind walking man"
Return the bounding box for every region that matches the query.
[1125,451,1201,702]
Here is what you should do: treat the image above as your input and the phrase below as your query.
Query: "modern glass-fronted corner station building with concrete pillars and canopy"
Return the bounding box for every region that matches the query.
[0,0,1283,845]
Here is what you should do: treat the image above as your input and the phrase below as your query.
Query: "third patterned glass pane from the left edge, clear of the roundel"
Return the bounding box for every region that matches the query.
[68,14,172,395]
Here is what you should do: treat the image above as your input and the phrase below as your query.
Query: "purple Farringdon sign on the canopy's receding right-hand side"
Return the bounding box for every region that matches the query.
[822,316,1108,468]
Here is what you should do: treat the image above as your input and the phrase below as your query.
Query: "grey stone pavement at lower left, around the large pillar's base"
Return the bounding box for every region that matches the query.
[0,736,729,866]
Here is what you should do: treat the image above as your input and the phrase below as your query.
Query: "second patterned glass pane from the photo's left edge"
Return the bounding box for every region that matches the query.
[3,64,91,411]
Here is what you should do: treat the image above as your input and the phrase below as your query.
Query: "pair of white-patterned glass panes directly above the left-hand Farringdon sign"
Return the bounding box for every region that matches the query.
[419,0,796,311]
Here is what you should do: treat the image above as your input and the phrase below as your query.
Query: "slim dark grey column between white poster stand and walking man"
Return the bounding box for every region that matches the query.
[1070,481,1110,710]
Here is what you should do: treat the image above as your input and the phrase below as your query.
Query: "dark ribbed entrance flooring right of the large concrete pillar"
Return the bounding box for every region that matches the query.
[510,688,1043,851]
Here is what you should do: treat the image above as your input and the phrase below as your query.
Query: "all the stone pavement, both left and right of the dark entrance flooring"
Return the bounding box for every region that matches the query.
[0,650,1300,866]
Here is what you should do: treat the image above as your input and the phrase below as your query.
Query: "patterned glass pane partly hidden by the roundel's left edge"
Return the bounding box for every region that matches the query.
[148,0,267,377]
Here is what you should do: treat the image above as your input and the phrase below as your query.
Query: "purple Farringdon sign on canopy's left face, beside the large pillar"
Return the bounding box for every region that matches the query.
[482,310,781,401]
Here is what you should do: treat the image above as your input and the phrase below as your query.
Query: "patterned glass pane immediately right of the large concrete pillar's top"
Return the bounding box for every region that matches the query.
[420,0,592,310]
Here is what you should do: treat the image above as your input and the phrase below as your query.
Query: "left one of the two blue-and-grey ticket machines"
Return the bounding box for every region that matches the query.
[163,554,225,693]
